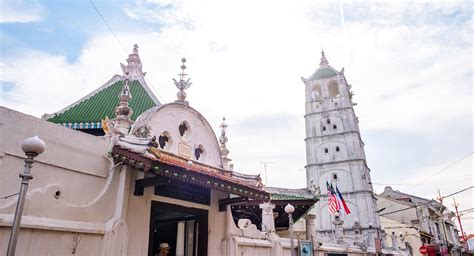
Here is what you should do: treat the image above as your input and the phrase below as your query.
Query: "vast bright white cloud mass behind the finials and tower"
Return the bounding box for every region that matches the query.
[1,1,472,232]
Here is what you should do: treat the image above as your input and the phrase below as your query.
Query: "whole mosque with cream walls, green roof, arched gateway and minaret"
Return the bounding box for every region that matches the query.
[0,45,444,256]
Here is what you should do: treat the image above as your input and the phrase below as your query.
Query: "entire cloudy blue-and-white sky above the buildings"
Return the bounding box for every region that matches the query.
[0,0,474,233]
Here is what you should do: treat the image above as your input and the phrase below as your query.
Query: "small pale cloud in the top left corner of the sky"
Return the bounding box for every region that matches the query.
[0,0,45,23]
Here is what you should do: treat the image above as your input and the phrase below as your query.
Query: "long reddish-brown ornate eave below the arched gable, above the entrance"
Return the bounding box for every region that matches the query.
[112,144,270,201]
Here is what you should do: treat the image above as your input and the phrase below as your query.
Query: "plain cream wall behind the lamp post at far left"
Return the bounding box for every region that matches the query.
[0,107,119,255]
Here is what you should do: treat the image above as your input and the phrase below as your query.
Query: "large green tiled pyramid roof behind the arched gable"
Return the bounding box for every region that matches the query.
[48,80,156,125]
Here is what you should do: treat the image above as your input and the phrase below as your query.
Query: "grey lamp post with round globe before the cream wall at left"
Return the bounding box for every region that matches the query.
[7,136,46,256]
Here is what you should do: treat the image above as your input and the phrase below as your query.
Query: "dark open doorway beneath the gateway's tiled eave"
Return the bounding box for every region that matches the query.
[148,201,208,256]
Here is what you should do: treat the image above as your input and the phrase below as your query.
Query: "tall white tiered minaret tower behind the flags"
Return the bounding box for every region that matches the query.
[302,52,380,247]
